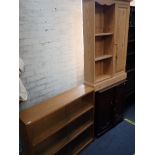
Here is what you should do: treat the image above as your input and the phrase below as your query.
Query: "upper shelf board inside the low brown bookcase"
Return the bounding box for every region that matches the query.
[33,105,94,146]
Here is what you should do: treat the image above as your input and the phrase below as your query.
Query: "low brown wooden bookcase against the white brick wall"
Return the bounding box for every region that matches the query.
[20,85,94,155]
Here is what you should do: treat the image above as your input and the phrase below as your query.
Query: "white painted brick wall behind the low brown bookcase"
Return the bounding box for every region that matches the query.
[19,0,84,110]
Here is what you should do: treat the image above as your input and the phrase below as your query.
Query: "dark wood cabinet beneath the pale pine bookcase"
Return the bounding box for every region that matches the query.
[95,83,125,137]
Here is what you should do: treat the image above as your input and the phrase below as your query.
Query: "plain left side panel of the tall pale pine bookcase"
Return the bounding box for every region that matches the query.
[83,0,95,84]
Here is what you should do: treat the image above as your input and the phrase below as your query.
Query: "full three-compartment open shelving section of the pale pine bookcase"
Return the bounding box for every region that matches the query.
[95,2,115,82]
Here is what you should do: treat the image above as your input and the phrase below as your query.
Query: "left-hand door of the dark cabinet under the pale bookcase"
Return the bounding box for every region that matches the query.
[95,89,113,136]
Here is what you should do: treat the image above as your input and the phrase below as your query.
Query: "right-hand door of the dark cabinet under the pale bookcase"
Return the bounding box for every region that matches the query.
[113,83,125,125]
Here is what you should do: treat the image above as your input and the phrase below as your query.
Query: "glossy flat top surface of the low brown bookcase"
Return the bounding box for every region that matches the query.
[19,84,94,125]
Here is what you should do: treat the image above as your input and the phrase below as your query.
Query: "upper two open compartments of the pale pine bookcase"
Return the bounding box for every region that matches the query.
[95,3,114,61]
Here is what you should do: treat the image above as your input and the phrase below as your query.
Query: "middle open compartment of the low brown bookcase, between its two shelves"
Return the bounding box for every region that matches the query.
[36,110,93,155]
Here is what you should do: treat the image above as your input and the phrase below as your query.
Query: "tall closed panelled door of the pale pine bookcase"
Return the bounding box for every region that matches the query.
[115,4,130,73]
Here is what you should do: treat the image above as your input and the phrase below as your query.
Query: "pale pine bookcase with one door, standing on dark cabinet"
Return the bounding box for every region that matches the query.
[83,0,130,91]
